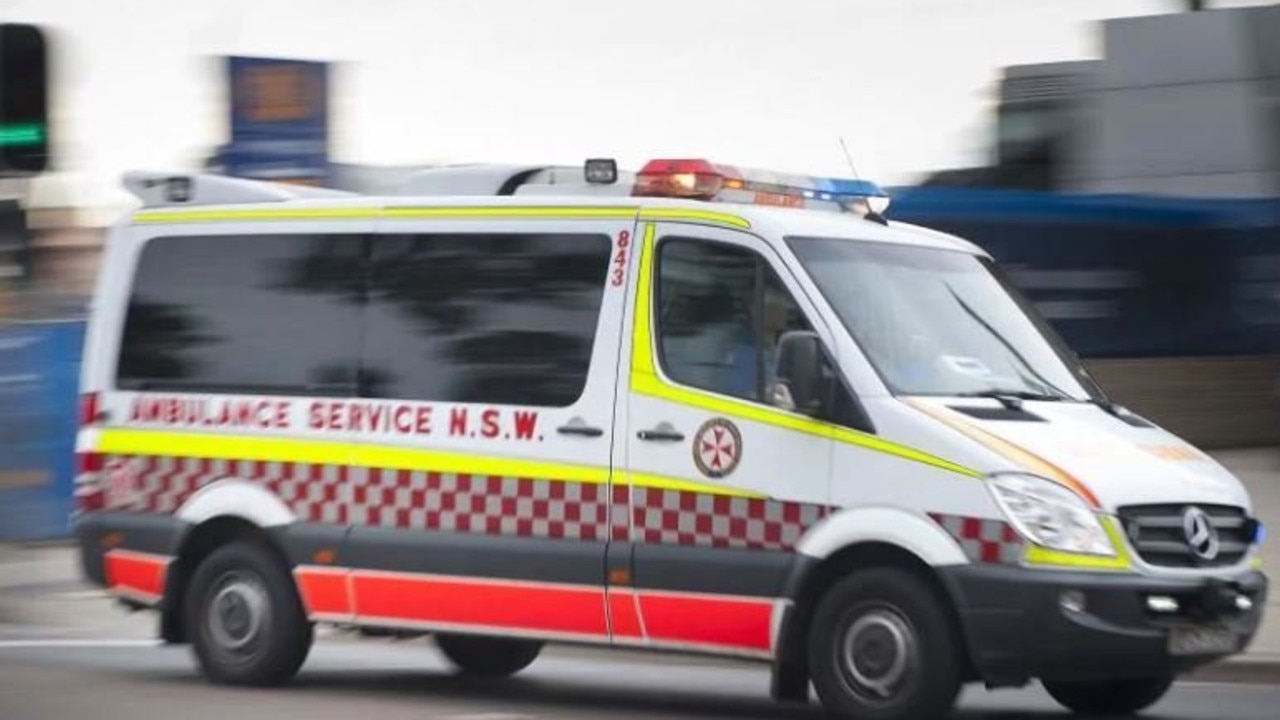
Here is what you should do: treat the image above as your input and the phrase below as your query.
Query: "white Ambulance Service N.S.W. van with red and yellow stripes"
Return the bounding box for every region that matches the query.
[76,160,1267,720]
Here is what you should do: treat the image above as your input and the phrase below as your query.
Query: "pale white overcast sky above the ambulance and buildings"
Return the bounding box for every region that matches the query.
[0,0,1267,219]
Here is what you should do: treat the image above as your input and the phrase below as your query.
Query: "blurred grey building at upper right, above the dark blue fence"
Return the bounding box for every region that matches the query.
[925,6,1280,199]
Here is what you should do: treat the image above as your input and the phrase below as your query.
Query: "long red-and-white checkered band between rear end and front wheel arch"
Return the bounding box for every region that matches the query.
[90,456,829,550]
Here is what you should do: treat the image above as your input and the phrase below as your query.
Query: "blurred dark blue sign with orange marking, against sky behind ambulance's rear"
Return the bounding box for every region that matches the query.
[221,56,329,184]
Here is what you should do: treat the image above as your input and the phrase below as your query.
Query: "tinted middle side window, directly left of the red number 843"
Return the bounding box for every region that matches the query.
[361,233,611,407]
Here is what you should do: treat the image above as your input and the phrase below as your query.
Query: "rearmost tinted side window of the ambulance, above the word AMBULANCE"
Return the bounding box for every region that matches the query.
[116,234,366,395]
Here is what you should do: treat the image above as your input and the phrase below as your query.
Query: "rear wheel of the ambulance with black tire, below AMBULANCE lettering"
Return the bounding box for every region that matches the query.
[183,541,314,687]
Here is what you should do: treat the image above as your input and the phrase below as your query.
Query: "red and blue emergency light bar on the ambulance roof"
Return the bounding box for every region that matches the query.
[631,159,890,217]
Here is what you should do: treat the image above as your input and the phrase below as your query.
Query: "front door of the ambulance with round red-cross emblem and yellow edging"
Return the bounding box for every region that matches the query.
[611,223,832,656]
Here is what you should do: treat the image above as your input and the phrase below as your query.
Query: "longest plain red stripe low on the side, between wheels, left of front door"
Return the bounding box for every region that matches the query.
[352,571,608,637]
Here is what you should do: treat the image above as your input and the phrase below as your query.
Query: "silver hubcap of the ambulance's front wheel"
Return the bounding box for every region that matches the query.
[841,610,916,700]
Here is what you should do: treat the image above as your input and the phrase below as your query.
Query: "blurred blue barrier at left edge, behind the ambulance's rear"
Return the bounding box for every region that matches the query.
[0,320,84,541]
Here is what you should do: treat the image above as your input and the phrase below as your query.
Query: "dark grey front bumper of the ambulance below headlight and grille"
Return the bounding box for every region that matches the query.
[942,565,1267,685]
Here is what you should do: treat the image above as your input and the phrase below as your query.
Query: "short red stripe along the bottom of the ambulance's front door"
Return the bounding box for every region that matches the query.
[640,593,773,652]
